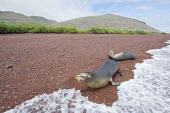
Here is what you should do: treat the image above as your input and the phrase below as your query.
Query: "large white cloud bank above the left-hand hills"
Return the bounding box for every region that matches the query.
[0,0,95,21]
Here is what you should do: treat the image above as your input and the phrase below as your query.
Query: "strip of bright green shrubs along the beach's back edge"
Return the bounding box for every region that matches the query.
[0,22,165,34]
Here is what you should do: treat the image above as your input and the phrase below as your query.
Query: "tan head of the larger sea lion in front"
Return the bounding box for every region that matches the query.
[75,72,93,84]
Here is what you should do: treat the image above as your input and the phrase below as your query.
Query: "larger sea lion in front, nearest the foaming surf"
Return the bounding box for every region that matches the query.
[75,60,124,88]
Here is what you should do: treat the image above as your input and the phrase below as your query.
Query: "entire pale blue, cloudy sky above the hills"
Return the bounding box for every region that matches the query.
[0,0,170,33]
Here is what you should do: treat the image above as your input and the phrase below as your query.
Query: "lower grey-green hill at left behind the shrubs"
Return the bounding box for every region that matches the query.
[0,11,57,25]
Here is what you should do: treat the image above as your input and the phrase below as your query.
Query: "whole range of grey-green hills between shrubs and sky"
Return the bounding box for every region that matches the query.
[0,11,159,32]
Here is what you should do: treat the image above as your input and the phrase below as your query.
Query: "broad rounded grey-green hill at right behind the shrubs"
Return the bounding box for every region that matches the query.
[56,14,159,32]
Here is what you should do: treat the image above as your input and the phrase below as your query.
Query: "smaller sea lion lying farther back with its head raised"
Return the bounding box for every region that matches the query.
[108,51,135,61]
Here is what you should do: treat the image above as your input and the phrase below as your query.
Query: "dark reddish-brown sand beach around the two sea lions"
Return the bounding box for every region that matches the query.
[0,34,170,112]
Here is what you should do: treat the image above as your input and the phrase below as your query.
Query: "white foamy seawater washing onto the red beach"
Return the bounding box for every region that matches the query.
[6,41,170,113]
